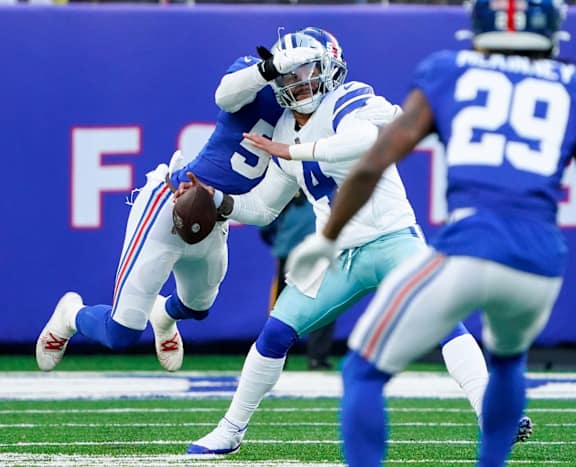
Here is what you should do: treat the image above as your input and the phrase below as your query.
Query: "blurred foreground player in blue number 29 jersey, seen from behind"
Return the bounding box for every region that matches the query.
[288,0,576,467]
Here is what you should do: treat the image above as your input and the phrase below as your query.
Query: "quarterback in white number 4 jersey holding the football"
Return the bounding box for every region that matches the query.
[186,28,528,458]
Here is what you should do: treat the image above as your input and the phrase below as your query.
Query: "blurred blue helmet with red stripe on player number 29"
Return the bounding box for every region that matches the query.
[472,0,566,51]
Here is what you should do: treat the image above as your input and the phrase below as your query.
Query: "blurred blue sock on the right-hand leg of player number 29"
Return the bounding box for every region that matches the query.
[478,354,526,467]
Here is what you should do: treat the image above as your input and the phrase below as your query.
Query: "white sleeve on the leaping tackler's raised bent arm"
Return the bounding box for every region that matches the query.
[214,64,268,113]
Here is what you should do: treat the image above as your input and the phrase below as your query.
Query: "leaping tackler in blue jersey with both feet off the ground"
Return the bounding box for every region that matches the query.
[36,44,316,371]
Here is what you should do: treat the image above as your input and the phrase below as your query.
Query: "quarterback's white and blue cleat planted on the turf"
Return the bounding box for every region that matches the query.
[186,417,247,459]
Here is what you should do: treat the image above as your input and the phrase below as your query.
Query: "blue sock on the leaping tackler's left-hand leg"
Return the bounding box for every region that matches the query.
[76,305,143,350]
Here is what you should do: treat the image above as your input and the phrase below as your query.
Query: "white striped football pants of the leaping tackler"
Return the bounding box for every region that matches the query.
[112,164,228,330]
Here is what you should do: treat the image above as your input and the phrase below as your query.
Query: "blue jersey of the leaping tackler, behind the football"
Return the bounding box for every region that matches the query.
[171,57,283,194]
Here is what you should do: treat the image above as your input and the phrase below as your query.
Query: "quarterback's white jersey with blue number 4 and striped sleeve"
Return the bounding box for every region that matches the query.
[231,82,416,249]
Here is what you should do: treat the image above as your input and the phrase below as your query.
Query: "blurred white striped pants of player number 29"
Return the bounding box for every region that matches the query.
[348,248,562,374]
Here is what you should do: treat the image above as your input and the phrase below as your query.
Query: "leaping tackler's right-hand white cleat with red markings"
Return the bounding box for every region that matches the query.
[150,296,184,371]
